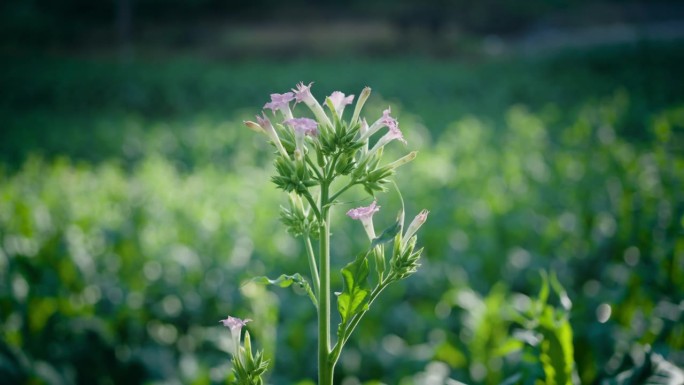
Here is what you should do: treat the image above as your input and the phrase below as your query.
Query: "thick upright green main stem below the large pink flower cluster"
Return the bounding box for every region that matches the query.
[318,182,333,385]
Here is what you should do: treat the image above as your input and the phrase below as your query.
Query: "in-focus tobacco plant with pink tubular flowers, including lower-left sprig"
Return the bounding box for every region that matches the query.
[232,83,428,385]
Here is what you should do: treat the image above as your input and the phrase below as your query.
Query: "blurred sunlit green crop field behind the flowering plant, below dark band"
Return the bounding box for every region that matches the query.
[0,40,684,385]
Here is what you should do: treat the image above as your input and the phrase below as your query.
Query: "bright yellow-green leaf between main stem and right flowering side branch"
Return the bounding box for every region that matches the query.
[337,254,370,324]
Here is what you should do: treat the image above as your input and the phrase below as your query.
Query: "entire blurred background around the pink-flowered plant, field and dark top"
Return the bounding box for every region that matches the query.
[0,0,684,385]
